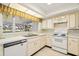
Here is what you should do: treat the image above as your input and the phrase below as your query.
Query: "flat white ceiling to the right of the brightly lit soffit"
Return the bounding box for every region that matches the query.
[19,3,79,18]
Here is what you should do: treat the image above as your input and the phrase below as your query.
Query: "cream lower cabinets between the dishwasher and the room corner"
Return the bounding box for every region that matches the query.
[27,36,45,56]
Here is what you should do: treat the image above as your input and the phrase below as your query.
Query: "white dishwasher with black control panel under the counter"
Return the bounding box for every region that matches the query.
[3,39,27,56]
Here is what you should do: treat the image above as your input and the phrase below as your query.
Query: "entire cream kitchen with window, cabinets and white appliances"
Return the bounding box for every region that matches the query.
[0,3,79,56]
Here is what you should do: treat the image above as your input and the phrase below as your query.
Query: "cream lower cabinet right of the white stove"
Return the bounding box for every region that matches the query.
[68,37,79,55]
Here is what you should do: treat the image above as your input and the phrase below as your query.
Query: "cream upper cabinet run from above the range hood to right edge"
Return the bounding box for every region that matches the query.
[53,12,79,29]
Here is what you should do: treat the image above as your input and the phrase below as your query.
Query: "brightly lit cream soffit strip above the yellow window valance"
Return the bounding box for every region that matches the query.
[3,3,42,18]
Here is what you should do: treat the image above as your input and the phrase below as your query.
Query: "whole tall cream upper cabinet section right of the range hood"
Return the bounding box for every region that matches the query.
[68,13,79,29]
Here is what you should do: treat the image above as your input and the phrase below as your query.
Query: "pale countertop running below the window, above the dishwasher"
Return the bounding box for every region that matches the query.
[0,33,52,44]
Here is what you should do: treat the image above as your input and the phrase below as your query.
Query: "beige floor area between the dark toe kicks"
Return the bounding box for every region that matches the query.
[34,47,68,56]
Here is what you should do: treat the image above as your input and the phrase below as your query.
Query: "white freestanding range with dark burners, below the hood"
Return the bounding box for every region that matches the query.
[52,30,67,54]
